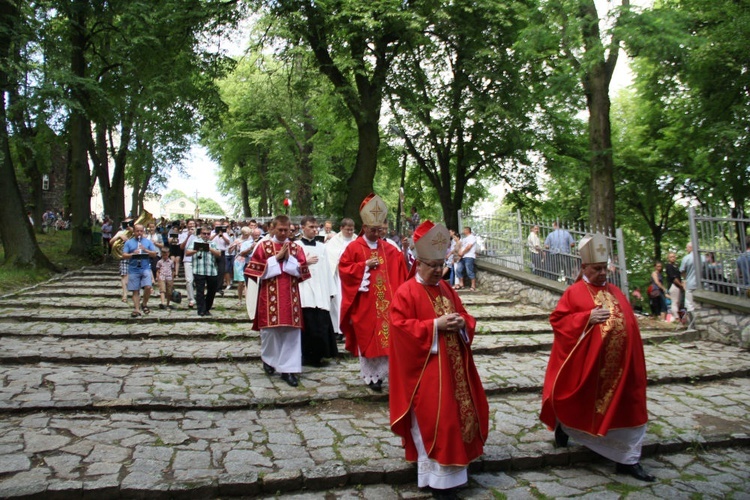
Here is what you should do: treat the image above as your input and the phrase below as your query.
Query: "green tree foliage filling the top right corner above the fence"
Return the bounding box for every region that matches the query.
[628,0,750,213]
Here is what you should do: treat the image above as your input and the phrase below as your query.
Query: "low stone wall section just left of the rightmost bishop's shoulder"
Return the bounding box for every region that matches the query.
[476,260,566,311]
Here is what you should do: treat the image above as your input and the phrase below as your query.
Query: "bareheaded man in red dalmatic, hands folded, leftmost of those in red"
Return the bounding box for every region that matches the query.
[245,215,310,387]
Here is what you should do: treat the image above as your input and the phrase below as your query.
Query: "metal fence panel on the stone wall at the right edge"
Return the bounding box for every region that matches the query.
[690,207,750,298]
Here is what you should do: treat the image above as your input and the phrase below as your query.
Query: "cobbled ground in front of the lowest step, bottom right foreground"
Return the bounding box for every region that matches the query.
[278,448,750,500]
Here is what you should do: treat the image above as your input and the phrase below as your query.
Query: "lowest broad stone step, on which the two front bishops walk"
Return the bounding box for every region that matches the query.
[0,379,750,498]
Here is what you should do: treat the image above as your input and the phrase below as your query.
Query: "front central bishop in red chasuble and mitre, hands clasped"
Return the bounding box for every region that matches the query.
[390,221,489,498]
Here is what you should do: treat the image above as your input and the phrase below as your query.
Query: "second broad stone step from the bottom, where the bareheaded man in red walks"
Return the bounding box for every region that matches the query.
[0,339,750,412]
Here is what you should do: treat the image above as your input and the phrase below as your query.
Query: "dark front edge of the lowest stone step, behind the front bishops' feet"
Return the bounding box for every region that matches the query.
[6,433,750,499]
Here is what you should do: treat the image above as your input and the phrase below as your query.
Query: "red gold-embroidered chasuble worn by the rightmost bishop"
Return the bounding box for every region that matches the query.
[540,280,648,436]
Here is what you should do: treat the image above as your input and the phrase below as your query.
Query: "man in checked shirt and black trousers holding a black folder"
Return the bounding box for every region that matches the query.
[185,226,221,316]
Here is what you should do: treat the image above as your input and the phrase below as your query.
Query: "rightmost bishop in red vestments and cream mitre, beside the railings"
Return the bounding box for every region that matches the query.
[540,233,654,482]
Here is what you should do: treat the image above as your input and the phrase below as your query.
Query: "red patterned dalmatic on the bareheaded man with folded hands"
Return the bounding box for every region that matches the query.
[245,240,310,331]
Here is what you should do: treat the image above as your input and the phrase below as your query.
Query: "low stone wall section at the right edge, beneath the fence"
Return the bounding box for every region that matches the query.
[693,290,750,348]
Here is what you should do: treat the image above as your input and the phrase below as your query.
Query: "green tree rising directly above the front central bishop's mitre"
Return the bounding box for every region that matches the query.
[388,0,535,229]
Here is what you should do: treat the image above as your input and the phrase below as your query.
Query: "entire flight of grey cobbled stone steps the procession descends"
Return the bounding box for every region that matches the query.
[0,268,750,499]
